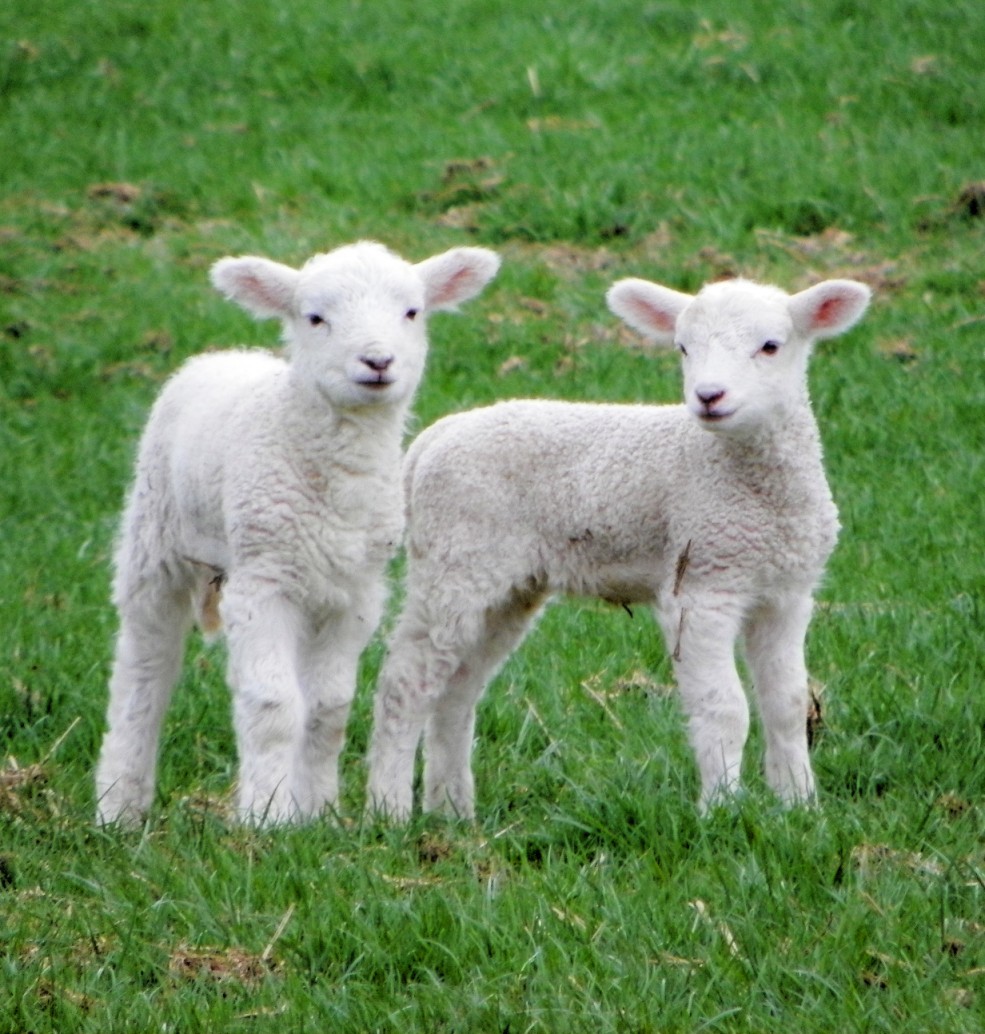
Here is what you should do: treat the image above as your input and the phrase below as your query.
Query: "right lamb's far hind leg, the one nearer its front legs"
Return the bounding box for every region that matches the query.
[424,595,542,819]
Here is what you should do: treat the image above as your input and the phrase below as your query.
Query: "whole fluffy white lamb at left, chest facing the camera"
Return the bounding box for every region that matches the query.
[96,241,499,824]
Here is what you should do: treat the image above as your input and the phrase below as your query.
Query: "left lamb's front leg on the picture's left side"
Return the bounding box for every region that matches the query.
[220,574,305,823]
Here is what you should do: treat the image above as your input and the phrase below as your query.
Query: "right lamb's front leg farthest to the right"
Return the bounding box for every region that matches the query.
[745,596,814,803]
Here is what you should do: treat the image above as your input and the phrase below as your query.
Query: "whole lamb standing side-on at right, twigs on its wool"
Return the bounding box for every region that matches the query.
[367,278,870,820]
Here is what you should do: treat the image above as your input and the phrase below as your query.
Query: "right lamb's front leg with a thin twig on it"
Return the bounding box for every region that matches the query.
[659,596,749,811]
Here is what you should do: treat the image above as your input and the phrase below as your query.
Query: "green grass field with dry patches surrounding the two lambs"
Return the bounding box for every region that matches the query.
[0,0,985,1034]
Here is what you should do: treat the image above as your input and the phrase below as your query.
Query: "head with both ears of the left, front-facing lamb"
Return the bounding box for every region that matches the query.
[212,241,499,408]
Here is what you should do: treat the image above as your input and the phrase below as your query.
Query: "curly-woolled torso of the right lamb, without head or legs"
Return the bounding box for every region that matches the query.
[406,400,837,602]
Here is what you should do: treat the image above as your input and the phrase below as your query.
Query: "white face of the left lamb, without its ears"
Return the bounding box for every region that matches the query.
[284,244,427,407]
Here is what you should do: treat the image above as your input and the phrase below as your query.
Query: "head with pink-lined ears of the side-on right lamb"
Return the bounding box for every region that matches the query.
[607,279,870,433]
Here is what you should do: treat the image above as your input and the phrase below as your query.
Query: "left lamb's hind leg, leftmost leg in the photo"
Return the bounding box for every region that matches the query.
[96,577,191,824]
